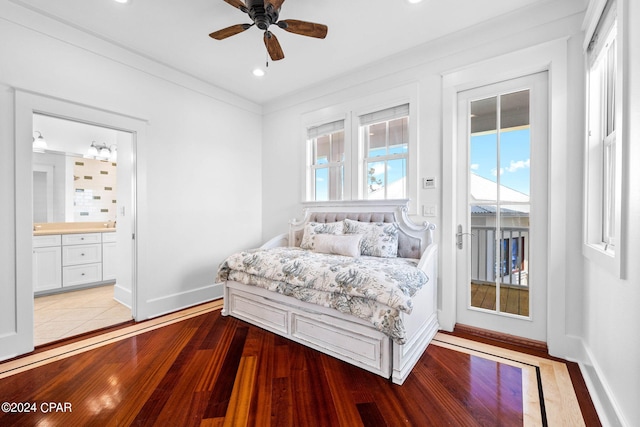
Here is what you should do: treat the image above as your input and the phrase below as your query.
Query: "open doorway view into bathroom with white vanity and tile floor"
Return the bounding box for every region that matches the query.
[32,113,134,347]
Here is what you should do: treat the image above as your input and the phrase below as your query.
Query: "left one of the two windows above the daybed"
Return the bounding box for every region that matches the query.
[307,120,345,201]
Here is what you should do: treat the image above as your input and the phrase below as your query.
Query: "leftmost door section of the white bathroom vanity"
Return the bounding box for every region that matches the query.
[33,234,62,292]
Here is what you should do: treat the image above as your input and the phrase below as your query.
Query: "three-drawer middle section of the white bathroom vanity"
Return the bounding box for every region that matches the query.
[62,233,102,287]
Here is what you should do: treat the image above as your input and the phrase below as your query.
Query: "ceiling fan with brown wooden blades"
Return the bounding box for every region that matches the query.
[209,0,328,61]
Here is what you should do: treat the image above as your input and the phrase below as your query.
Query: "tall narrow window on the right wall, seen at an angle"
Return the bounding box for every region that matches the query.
[585,0,622,274]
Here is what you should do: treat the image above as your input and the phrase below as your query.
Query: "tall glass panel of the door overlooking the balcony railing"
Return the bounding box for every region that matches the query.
[469,90,531,317]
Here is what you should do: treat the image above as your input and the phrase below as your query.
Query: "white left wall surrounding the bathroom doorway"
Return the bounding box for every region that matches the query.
[0,0,262,353]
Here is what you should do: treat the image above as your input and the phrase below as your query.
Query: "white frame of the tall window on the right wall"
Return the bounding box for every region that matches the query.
[582,0,628,278]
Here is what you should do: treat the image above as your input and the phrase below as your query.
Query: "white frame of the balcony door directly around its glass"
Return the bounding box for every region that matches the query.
[456,72,549,342]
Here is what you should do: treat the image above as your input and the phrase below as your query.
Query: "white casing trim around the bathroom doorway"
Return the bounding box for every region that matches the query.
[0,88,149,359]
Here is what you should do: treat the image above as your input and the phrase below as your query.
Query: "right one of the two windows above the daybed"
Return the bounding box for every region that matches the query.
[359,104,409,199]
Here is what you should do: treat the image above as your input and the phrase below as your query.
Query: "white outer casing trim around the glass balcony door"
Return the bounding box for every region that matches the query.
[438,39,580,357]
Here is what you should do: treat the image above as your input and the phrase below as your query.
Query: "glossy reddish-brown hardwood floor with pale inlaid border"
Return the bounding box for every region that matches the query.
[0,302,598,426]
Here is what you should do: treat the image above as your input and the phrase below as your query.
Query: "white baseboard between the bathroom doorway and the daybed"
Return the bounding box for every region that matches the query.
[136,283,224,321]
